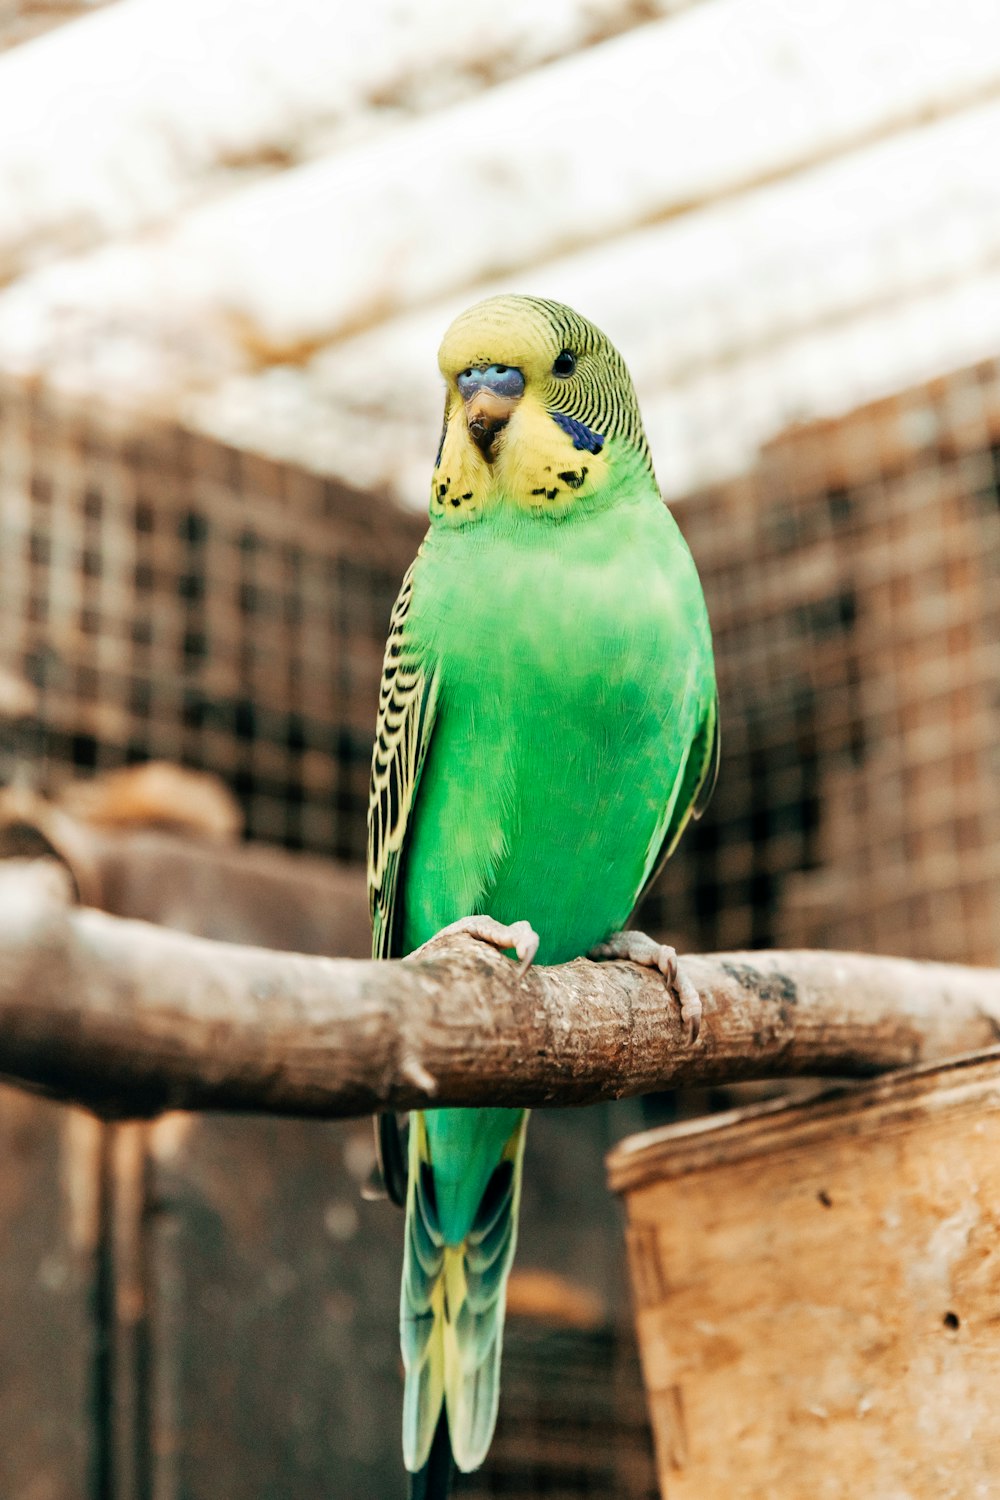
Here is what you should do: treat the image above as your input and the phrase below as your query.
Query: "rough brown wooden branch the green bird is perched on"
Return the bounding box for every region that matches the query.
[0,861,1000,1118]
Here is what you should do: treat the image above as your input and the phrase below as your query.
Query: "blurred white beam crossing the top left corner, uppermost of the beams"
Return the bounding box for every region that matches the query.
[0,0,694,282]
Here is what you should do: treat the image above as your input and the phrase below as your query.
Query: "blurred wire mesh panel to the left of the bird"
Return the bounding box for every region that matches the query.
[0,384,423,858]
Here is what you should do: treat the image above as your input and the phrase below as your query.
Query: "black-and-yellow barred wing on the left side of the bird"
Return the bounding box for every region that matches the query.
[367,561,438,959]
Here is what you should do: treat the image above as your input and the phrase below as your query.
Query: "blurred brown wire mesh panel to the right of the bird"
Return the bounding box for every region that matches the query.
[643,362,1000,963]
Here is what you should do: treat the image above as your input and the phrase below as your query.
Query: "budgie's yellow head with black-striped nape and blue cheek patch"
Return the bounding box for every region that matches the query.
[430,296,654,525]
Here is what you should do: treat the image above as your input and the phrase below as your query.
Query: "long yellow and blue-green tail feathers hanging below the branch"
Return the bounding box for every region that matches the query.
[400,1112,525,1500]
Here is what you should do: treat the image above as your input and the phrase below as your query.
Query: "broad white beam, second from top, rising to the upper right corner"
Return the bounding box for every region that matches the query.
[0,0,1000,396]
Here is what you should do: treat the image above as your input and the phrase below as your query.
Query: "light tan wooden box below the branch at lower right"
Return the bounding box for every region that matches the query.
[610,1056,1000,1500]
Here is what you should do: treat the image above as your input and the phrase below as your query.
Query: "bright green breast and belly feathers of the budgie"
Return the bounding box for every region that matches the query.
[399,495,715,963]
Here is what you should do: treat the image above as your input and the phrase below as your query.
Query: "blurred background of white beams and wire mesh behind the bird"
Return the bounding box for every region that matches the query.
[0,0,1000,1500]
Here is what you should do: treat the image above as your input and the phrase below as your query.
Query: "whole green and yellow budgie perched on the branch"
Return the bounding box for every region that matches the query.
[369,296,718,1500]
